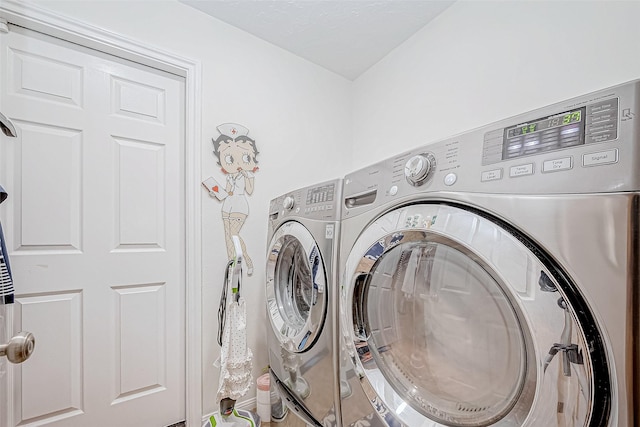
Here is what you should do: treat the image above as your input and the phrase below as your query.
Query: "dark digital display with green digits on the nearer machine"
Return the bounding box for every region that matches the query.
[502,107,586,160]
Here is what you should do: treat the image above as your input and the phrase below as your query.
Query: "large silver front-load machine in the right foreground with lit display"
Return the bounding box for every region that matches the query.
[339,81,640,427]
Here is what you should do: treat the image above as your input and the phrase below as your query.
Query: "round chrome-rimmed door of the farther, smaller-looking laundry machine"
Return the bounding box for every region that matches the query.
[266,221,327,353]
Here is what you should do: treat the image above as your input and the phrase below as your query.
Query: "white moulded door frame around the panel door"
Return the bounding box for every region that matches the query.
[0,0,202,426]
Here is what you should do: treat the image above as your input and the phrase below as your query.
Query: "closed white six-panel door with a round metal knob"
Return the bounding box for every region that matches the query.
[0,26,185,427]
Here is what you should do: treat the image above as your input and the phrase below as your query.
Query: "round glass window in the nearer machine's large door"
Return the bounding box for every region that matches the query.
[358,236,531,426]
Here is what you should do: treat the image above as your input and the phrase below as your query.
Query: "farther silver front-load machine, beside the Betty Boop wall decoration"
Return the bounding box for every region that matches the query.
[266,179,342,426]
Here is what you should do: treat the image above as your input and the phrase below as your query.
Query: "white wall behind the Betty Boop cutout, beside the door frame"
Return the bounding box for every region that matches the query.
[26,0,352,414]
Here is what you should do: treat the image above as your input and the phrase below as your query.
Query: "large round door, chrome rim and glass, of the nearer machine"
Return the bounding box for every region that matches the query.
[341,204,610,427]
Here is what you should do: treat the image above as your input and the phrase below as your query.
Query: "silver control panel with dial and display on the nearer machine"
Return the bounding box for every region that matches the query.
[343,80,640,213]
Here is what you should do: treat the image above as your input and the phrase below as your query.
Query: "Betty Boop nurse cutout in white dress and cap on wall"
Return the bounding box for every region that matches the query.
[202,123,258,275]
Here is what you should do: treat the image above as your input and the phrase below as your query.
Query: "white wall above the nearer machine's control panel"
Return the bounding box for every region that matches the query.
[353,1,640,168]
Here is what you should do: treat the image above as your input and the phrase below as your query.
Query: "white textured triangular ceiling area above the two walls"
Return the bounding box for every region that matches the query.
[179,0,454,80]
